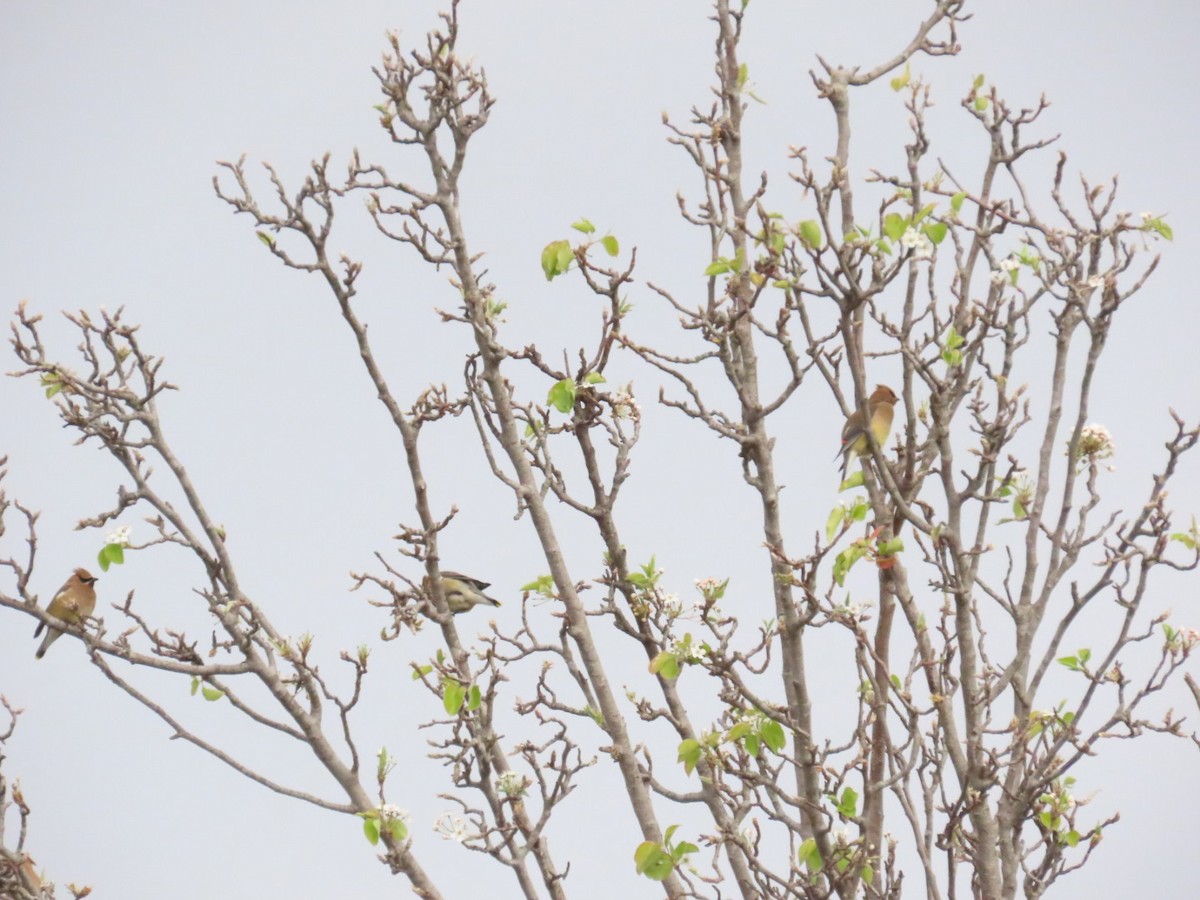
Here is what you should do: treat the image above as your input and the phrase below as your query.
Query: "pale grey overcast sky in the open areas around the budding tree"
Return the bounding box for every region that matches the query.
[0,0,1200,900]
